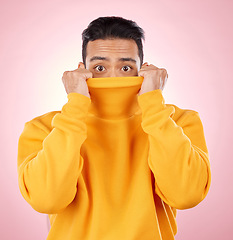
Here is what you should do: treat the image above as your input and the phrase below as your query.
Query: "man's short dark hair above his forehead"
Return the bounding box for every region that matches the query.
[82,16,145,67]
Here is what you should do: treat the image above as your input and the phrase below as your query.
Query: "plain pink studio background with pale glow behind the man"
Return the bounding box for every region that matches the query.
[0,0,233,240]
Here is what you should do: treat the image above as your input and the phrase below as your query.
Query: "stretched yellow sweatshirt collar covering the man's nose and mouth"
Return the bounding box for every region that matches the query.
[87,76,143,119]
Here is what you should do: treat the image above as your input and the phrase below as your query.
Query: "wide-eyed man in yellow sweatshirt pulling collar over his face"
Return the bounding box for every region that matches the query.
[18,17,211,240]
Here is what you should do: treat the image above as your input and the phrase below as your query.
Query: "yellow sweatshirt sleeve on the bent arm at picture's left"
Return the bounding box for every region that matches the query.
[17,93,91,214]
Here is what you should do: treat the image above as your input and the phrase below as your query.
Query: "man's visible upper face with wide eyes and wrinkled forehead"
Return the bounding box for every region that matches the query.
[86,39,140,78]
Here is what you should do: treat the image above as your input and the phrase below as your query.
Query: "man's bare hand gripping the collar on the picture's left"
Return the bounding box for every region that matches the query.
[62,62,92,98]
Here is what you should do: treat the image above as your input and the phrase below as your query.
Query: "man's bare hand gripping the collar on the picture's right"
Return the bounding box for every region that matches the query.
[138,62,168,96]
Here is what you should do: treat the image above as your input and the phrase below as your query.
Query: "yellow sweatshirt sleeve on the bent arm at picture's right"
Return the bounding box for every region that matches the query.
[138,89,211,209]
